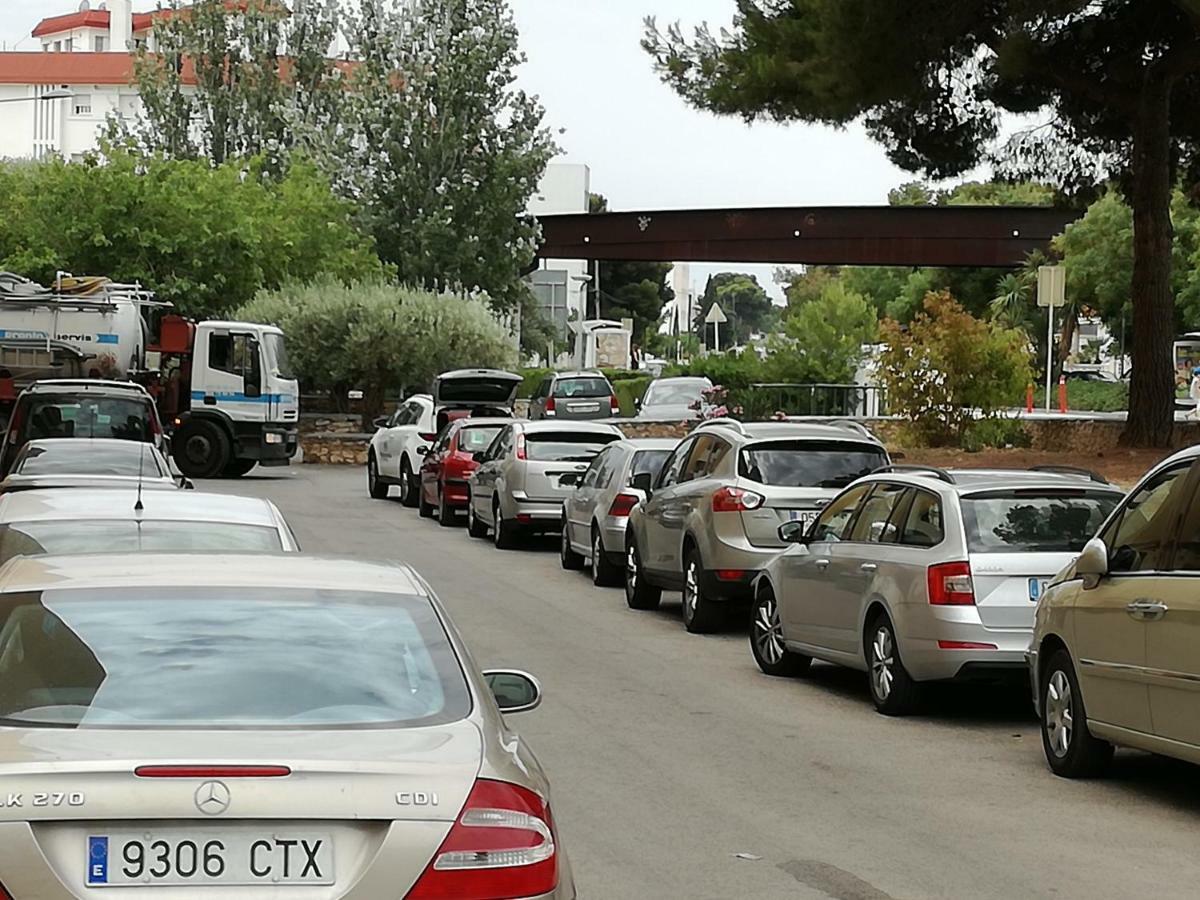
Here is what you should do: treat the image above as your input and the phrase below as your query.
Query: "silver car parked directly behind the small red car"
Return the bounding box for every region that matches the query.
[467,421,624,550]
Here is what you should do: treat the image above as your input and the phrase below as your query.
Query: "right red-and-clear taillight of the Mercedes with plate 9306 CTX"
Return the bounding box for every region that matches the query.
[407,779,558,900]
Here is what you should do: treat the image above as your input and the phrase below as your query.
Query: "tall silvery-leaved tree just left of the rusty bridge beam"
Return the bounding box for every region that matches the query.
[329,0,557,310]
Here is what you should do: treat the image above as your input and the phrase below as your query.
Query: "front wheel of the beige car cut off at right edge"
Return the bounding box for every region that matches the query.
[1040,650,1112,778]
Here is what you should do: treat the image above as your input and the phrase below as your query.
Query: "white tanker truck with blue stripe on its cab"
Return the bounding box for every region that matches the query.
[0,274,300,478]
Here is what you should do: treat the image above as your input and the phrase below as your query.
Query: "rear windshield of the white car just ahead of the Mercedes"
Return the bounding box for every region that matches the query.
[0,520,283,563]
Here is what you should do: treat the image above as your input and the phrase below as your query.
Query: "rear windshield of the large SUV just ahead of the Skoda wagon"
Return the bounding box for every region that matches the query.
[738,440,888,488]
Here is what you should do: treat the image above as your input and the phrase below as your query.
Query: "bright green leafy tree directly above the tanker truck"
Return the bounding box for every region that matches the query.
[0,154,384,317]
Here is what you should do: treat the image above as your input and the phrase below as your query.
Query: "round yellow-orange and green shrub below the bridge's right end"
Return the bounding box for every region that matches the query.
[880,290,1031,446]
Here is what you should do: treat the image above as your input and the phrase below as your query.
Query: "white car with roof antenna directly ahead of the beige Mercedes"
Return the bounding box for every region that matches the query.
[0,487,300,563]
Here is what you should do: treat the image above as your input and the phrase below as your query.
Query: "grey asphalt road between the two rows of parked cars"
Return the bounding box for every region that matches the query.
[220,466,1200,900]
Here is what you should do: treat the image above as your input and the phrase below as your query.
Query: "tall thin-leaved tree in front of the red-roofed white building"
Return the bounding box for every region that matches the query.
[110,0,344,174]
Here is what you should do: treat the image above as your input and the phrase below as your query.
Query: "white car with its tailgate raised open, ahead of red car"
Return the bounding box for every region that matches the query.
[367,368,521,506]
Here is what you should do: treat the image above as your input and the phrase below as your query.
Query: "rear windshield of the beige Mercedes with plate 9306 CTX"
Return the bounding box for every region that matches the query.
[0,586,470,730]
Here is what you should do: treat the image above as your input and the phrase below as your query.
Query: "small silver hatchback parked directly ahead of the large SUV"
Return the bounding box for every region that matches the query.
[559,438,679,586]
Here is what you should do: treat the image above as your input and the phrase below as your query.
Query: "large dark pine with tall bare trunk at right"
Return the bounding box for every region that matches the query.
[644,0,1200,446]
